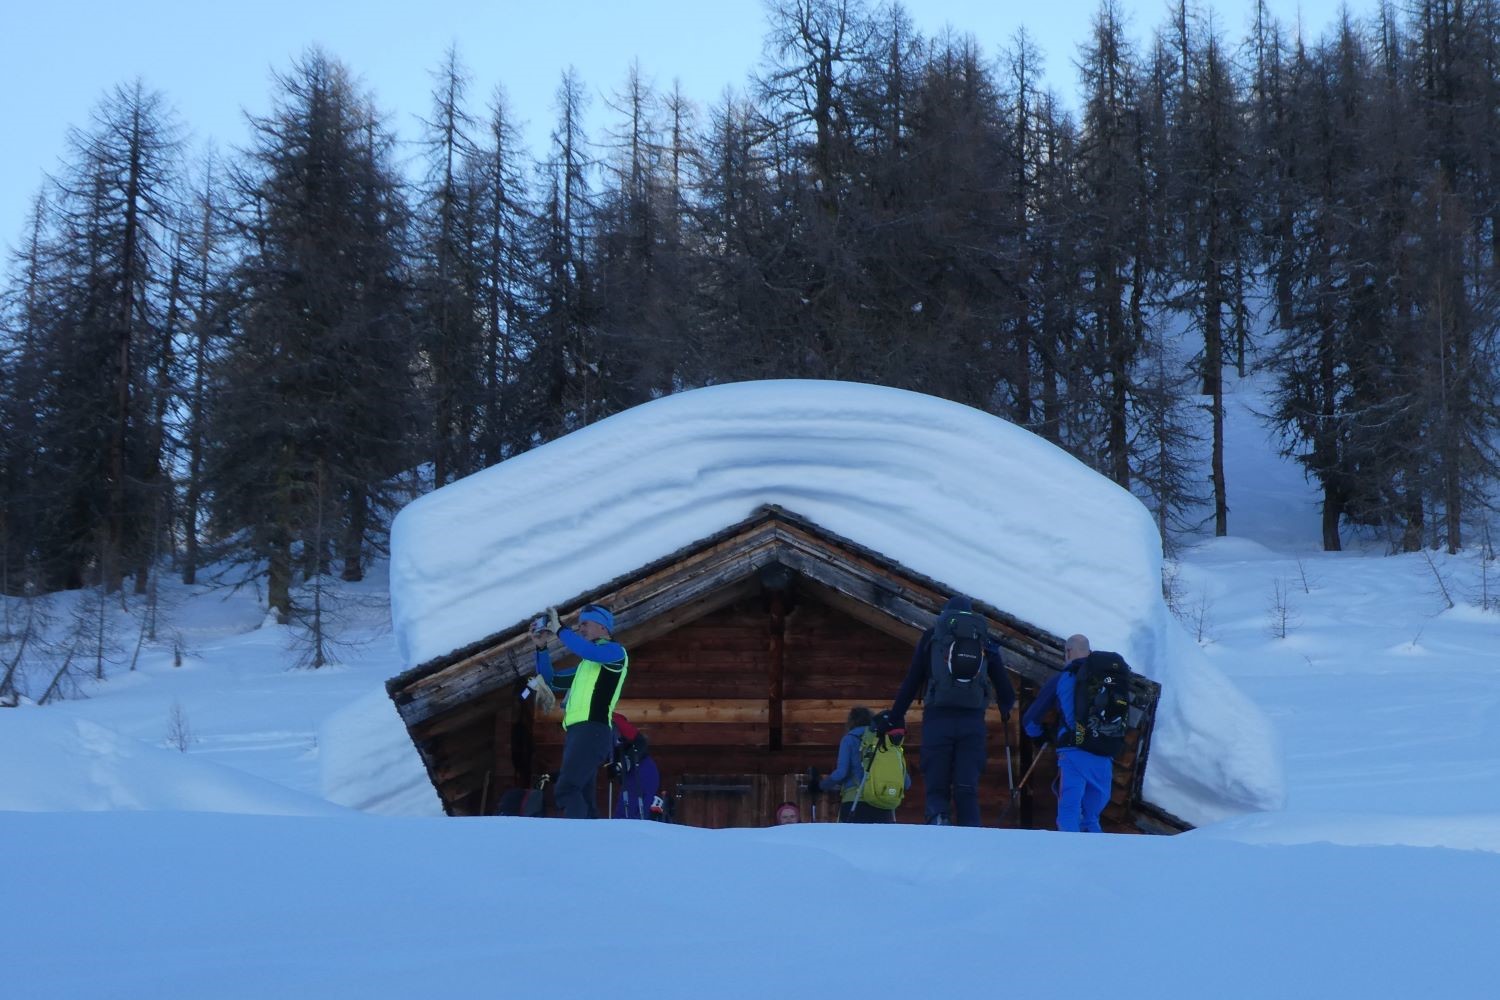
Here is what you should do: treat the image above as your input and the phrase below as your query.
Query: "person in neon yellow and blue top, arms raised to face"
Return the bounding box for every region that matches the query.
[537,604,630,820]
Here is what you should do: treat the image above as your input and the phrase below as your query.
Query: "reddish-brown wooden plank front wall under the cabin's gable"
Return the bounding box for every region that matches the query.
[534,595,1056,828]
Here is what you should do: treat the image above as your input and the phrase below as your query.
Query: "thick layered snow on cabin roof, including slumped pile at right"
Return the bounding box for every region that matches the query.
[390,381,1281,822]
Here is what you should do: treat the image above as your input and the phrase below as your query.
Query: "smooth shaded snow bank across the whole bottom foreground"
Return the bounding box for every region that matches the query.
[0,813,1500,1000]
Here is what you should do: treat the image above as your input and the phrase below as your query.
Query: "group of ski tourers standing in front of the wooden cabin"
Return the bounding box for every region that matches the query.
[501,595,1131,832]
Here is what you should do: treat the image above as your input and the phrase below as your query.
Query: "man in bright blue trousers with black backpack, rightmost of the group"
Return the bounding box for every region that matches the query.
[1022,636,1131,834]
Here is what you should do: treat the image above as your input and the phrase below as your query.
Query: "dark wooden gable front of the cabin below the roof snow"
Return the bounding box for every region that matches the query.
[387,507,1181,828]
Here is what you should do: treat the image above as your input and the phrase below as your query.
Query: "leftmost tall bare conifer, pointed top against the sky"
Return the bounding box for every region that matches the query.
[21,81,179,591]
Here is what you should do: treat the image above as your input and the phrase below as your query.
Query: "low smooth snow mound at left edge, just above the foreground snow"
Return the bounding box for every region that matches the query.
[0,708,344,816]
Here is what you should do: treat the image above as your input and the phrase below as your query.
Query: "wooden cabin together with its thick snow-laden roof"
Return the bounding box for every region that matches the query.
[387,382,1278,831]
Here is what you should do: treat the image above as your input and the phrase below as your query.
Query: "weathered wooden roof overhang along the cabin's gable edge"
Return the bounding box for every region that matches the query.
[386,505,1182,829]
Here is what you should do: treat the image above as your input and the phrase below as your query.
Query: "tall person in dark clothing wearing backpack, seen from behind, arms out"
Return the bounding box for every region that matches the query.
[890,595,1016,826]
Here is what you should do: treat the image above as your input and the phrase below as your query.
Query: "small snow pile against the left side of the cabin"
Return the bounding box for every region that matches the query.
[318,688,443,816]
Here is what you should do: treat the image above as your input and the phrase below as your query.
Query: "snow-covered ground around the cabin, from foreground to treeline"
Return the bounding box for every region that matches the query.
[0,379,1500,999]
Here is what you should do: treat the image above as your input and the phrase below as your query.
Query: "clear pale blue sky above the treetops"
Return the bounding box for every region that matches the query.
[0,0,1356,246]
